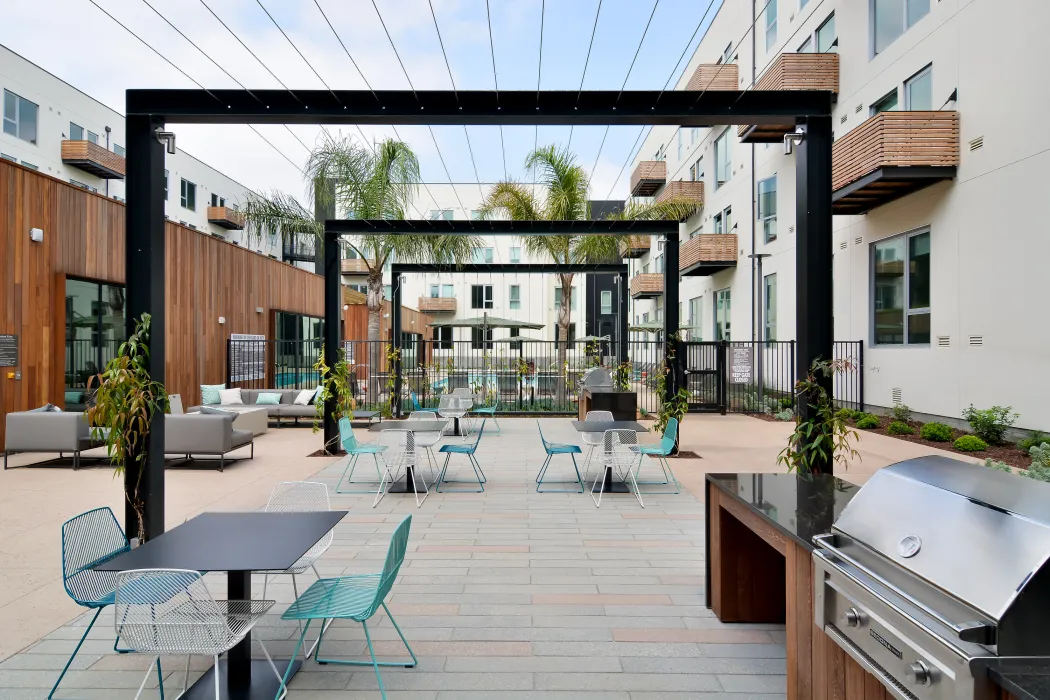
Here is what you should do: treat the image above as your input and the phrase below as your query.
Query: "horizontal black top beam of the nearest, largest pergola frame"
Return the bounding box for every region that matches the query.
[127,89,833,126]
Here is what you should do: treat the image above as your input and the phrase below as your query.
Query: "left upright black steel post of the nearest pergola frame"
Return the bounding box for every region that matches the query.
[124,116,165,538]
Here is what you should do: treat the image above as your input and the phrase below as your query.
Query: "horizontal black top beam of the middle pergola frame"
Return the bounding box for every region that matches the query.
[324,218,678,236]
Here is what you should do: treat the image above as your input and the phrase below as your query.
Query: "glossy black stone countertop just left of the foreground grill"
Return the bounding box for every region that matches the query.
[708,473,860,551]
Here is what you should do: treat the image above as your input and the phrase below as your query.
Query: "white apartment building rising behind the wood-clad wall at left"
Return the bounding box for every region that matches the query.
[0,46,281,256]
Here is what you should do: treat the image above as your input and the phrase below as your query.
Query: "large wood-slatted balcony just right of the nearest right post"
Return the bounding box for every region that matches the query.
[832,111,959,214]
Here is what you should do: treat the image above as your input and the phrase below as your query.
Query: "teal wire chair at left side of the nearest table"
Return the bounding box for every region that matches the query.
[47,508,147,700]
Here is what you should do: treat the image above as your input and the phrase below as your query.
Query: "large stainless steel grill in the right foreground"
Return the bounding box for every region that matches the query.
[813,457,1050,700]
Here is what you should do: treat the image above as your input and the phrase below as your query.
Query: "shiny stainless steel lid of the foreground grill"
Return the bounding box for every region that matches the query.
[833,455,1050,620]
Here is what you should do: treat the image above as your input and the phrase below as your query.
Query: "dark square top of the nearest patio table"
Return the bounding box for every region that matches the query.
[97,510,349,571]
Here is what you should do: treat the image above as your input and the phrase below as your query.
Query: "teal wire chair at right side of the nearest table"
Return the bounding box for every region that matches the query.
[278,515,419,700]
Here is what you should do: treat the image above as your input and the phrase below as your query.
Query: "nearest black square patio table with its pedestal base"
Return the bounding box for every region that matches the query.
[96,510,349,700]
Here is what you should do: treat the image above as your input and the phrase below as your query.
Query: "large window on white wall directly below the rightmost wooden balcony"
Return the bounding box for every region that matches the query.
[872,230,930,345]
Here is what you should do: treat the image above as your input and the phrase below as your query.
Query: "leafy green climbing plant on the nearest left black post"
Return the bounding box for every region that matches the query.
[86,314,169,543]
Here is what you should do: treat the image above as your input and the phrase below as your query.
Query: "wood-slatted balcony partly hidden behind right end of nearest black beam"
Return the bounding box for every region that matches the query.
[737,54,839,144]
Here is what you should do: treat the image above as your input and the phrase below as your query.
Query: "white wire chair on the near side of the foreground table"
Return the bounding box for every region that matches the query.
[113,569,287,700]
